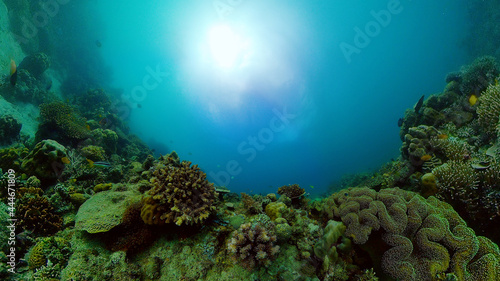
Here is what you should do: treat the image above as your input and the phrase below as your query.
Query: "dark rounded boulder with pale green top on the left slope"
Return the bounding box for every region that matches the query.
[21,139,67,181]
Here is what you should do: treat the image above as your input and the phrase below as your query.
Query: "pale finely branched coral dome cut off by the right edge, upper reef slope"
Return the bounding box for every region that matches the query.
[477,85,500,134]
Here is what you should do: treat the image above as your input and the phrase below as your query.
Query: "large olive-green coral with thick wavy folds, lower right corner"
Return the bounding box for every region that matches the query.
[330,185,500,280]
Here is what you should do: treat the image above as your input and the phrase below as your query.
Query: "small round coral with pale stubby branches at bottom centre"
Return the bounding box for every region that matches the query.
[227,223,280,268]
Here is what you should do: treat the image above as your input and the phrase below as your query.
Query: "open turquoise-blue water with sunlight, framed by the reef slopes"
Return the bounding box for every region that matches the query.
[95,0,470,195]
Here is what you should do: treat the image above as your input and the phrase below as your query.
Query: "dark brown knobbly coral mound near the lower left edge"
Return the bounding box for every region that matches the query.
[16,187,62,236]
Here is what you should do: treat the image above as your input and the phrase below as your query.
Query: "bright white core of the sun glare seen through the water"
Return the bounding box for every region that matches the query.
[209,25,245,69]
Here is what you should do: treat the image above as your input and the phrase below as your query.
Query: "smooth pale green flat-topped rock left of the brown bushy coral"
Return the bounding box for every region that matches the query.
[75,190,141,233]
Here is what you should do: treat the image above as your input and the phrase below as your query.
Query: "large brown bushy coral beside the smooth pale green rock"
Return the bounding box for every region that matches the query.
[141,159,217,225]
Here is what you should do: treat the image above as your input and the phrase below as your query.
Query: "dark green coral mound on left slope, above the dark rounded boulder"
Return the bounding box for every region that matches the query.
[36,102,89,144]
